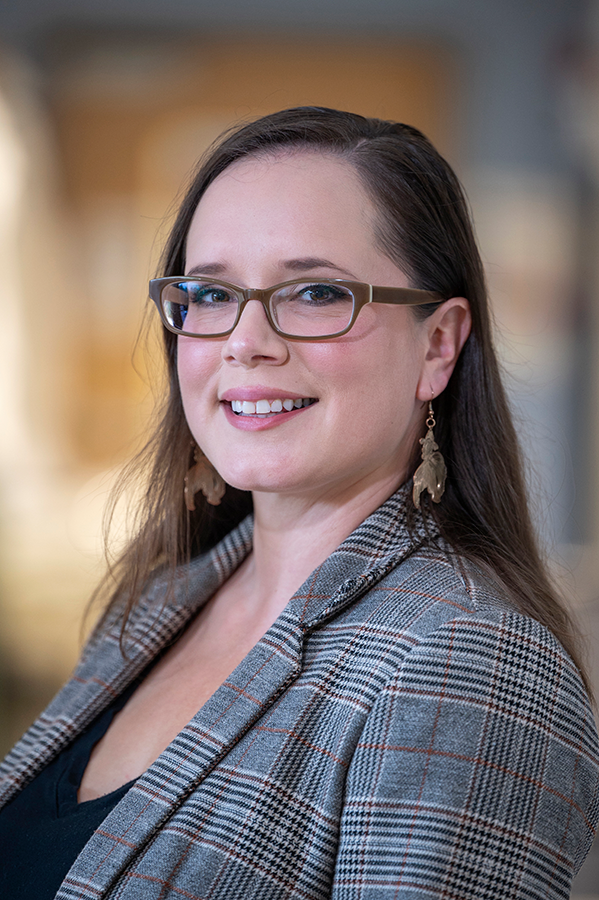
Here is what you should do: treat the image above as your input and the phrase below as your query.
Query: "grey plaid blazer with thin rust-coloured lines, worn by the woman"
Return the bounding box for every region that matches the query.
[0,487,599,900]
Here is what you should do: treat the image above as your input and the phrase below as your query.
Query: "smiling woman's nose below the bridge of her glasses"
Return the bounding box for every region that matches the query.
[222,300,289,369]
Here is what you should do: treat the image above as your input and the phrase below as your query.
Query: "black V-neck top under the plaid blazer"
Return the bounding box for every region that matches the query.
[0,683,137,900]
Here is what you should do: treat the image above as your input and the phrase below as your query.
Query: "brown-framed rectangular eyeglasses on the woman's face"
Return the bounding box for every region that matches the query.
[150,275,444,341]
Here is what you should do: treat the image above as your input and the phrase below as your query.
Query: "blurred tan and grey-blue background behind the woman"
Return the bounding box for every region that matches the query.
[0,0,599,898]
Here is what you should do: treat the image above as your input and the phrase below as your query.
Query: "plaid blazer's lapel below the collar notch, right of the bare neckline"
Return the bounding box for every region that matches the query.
[56,592,304,900]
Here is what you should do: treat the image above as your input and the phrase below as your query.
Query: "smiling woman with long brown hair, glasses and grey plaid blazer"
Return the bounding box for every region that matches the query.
[0,108,598,900]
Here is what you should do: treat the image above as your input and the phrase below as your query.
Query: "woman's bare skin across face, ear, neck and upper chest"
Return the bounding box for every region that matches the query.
[79,151,470,800]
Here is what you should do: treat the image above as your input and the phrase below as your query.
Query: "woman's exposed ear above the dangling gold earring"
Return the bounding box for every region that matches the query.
[416,297,472,402]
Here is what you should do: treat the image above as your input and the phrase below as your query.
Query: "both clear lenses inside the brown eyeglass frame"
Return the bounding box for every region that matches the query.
[162,280,354,337]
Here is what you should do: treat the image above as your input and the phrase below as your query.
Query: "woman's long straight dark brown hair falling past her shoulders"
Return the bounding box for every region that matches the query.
[94,107,588,687]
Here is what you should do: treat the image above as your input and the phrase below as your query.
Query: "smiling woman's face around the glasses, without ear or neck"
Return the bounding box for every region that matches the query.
[178,151,440,502]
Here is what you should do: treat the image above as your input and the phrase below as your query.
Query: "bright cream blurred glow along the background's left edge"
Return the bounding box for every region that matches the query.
[0,60,104,700]
